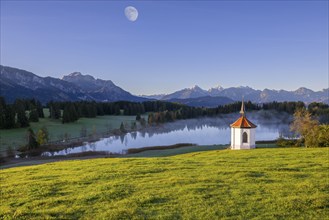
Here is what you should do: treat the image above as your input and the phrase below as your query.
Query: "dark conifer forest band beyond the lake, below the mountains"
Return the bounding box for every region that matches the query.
[0,97,329,129]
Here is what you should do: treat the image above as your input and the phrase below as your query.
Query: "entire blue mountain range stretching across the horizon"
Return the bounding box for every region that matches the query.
[0,65,329,107]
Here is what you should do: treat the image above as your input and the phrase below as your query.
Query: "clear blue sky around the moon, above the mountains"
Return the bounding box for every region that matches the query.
[0,0,329,95]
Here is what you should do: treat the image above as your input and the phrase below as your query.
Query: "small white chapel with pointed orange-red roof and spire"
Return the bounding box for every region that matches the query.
[231,101,257,150]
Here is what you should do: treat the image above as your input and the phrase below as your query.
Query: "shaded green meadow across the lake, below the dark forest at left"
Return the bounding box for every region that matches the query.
[0,109,140,154]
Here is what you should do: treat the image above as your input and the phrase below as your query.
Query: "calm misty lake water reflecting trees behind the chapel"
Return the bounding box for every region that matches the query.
[43,112,293,156]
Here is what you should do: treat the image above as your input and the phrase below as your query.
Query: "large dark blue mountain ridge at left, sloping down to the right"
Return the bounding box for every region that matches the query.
[0,65,147,103]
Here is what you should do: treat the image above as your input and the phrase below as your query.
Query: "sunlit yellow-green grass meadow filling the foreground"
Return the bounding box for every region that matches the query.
[0,148,329,219]
